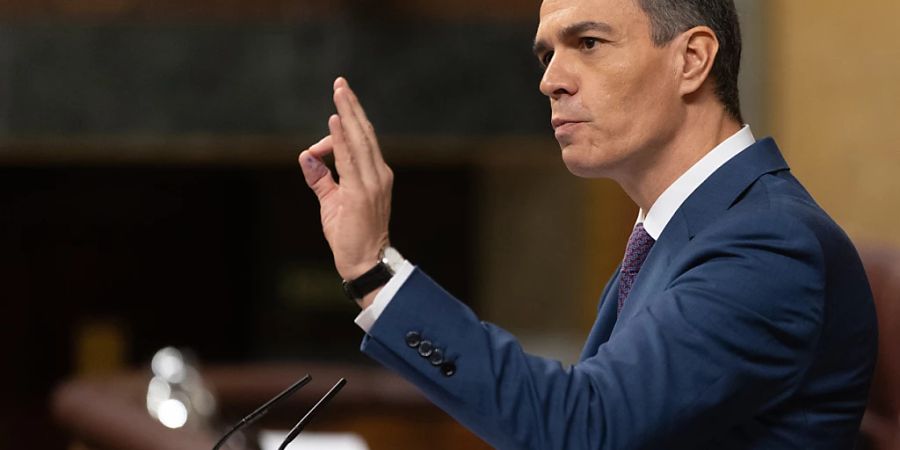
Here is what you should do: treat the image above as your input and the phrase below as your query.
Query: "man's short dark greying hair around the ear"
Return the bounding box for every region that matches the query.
[636,0,744,123]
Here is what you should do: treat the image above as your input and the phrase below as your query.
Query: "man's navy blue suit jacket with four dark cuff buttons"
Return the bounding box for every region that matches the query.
[362,139,876,450]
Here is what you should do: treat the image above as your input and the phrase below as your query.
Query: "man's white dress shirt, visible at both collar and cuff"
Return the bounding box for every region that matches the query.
[355,125,756,333]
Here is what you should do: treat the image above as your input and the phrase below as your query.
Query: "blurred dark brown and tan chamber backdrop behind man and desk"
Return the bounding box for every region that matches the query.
[0,0,900,449]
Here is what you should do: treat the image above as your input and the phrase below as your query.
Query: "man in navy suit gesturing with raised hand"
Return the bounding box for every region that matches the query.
[300,0,876,449]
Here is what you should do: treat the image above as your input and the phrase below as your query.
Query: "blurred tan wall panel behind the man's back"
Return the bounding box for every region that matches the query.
[770,0,900,244]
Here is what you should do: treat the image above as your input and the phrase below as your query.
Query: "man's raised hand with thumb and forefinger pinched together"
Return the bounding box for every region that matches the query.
[299,78,394,307]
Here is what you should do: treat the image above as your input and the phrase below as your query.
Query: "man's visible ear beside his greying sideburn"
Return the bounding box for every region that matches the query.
[678,26,719,95]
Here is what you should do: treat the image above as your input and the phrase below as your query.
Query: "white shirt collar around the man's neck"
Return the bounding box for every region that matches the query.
[637,125,756,240]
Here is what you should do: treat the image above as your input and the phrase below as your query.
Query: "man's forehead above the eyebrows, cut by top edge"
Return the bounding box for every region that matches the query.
[537,0,649,39]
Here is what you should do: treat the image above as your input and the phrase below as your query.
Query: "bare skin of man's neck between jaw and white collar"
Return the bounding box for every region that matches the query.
[616,108,741,213]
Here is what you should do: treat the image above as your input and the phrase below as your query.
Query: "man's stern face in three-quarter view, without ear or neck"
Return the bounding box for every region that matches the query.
[535,0,683,179]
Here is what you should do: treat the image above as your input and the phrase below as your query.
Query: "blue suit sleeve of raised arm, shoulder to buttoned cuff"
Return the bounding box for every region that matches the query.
[362,216,824,450]
